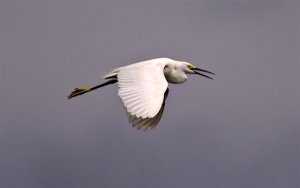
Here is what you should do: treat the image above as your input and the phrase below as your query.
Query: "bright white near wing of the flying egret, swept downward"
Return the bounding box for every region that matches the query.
[117,62,168,119]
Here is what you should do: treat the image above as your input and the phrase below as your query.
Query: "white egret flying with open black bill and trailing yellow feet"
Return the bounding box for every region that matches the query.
[67,58,214,130]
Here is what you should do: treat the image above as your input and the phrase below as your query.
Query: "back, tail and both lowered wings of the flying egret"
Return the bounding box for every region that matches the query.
[103,58,173,131]
